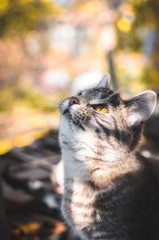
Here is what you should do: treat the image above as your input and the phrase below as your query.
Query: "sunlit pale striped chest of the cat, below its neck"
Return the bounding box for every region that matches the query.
[63,180,96,230]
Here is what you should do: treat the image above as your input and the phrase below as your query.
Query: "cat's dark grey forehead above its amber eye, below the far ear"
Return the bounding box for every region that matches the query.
[77,88,114,100]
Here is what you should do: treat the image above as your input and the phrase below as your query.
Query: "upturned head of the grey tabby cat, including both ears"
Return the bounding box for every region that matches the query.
[59,74,156,162]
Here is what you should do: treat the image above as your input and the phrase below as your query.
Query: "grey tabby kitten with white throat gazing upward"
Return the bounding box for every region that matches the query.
[58,74,159,240]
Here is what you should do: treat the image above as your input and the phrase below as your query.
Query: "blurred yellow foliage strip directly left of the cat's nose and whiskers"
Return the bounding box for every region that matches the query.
[0,81,59,113]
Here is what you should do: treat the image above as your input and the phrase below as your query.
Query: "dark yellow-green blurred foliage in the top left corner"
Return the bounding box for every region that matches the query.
[0,0,60,37]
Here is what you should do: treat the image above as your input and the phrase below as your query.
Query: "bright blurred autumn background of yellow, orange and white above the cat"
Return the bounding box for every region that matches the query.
[0,0,159,239]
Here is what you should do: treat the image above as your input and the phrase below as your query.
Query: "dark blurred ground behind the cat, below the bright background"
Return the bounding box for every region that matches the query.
[0,126,159,240]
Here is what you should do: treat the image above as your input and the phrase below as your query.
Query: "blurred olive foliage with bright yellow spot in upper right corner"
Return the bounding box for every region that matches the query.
[117,0,157,51]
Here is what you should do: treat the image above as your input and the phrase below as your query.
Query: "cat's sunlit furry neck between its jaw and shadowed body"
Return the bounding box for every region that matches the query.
[63,149,143,188]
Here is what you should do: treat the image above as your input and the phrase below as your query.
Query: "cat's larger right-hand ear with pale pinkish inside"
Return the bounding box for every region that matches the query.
[127,91,156,127]
